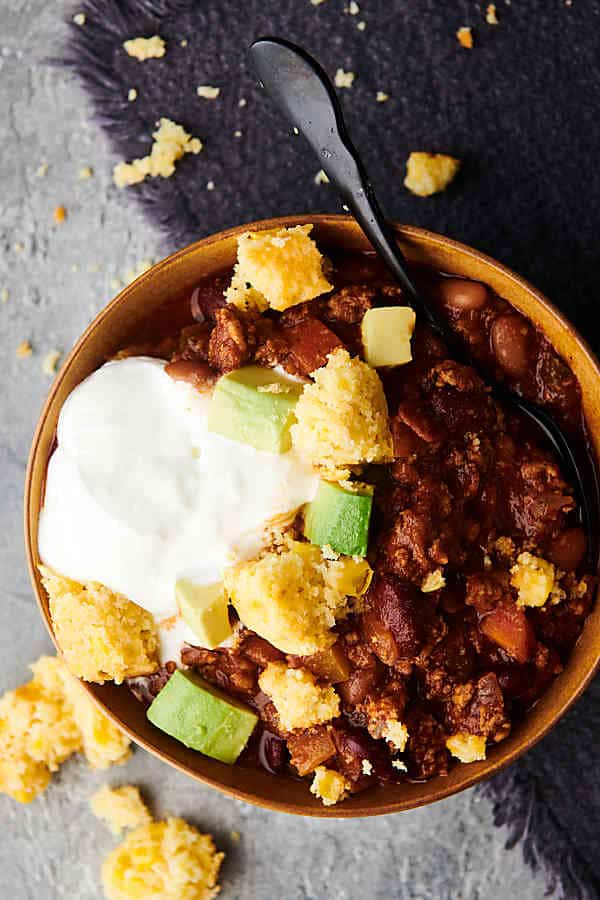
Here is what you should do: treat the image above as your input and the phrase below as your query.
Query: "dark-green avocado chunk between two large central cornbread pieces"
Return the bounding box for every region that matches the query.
[304,481,373,556]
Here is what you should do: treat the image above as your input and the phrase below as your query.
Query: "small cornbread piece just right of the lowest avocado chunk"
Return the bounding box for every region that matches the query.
[258,662,340,731]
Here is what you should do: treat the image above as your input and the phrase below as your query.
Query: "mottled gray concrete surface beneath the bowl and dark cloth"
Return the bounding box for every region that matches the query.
[0,0,545,900]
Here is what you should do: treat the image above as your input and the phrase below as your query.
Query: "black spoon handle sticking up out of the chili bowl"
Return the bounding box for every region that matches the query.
[249,37,436,333]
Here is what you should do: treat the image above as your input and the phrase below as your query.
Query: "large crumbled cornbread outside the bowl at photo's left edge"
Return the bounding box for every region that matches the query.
[0,656,129,803]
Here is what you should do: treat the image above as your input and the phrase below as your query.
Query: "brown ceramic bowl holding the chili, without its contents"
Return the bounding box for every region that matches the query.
[25,216,600,817]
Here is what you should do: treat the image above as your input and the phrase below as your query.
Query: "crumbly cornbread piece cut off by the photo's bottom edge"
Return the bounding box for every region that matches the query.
[102,818,224,900]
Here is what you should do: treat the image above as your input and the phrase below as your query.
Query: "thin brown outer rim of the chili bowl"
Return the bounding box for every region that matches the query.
[24,213,600,819]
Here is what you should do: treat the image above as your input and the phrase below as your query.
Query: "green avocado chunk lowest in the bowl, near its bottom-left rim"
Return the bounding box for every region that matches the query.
[146,669,258,765]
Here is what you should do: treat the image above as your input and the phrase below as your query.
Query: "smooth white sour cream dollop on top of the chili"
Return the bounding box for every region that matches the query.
[38,357,317,662]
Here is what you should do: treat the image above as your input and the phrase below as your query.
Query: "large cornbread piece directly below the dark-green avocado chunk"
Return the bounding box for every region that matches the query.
[224,542,354,656]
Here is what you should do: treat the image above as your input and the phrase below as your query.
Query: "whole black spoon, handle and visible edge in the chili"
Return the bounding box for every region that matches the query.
[248,37,600,571]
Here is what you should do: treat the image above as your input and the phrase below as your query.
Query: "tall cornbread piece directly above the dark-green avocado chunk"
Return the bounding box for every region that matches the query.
[292,350,393,481]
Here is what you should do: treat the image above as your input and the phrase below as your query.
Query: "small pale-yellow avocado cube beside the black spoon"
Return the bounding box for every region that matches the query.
[360,306,416,367]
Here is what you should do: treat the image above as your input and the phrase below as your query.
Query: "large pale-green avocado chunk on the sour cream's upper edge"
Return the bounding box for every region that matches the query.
[208,366,303,453]
